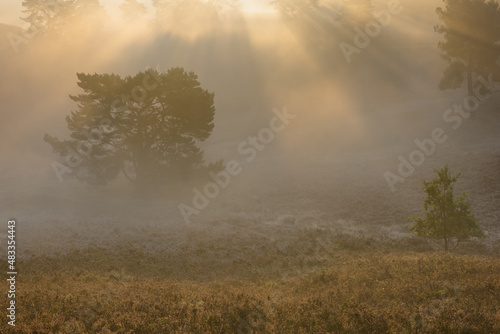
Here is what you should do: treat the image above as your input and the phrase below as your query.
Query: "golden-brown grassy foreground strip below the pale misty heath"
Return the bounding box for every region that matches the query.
[0,244,500,333]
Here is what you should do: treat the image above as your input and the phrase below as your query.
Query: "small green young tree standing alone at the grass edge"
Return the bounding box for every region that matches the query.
[408,166,484,250]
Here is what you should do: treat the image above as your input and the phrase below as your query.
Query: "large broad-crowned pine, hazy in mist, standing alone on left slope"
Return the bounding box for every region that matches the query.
[44,68,219,189]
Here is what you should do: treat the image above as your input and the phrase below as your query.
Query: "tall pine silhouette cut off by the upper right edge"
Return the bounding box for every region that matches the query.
[434,0,500,95]
